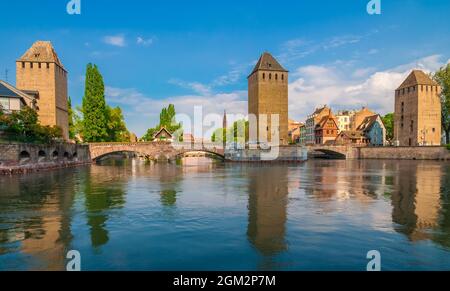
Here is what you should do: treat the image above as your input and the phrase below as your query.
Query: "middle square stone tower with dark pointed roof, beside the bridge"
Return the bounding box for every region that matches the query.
[248,52,289,145]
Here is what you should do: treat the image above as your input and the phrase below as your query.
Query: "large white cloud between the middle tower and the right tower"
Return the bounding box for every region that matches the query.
[289,55,445,120]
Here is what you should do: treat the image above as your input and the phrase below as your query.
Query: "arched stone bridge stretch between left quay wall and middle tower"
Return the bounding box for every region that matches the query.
[89,142,225,161]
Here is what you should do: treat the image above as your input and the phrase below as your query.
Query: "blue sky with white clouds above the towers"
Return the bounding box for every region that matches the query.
[0,0,450,135]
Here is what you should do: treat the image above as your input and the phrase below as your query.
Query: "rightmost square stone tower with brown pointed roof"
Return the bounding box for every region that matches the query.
[394,70,442,146]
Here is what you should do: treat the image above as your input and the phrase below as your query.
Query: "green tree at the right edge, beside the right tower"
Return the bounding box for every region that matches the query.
[434,64,450,144]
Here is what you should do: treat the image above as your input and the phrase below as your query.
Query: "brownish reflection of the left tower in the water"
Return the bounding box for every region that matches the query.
[0,170,76,270]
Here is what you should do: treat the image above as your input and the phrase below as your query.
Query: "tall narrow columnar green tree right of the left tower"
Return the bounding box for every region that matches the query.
[82,64,108,142]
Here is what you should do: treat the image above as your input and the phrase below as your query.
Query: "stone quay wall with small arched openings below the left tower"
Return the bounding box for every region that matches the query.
[0,143,92,175]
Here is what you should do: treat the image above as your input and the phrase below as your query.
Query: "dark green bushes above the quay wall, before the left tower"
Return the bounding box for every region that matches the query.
[0,106,62,144]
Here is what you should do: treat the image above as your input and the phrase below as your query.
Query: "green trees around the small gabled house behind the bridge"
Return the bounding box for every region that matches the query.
[142,104,183,142]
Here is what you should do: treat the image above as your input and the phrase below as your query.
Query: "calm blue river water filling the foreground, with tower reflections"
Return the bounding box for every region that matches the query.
[0,159,450,271]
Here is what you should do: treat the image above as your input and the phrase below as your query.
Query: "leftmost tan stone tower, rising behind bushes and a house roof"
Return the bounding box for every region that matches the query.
[16,41,69,140]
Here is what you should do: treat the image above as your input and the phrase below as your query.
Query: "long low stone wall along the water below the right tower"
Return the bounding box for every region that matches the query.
[359,147,450,160]
